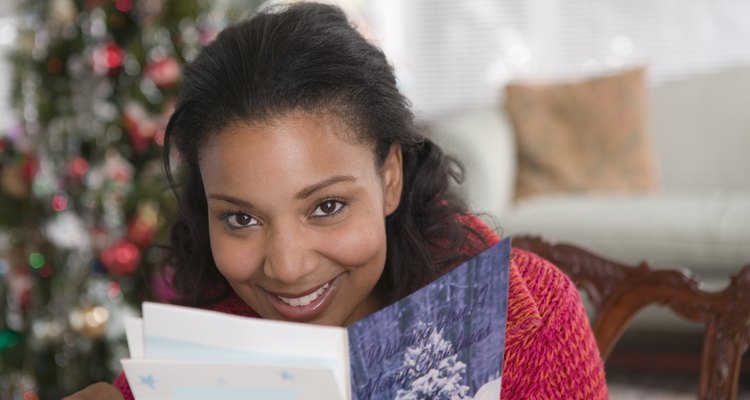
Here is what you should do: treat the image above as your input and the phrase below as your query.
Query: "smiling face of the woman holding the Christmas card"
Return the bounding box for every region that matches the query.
[199,113,402,325]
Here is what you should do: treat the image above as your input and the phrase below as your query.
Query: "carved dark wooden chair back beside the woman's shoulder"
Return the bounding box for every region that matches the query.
[513,236,750,400]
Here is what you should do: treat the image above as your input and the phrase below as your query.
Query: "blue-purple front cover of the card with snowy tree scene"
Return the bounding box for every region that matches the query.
[348,240,509,400]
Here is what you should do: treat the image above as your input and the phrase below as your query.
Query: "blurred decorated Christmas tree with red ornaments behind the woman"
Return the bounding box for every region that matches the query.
[0,0,260,399]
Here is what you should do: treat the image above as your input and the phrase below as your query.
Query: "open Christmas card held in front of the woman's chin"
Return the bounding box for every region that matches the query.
[122,239,510,400]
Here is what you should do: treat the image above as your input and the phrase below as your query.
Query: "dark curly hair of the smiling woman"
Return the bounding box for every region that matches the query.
[163,3,484,306]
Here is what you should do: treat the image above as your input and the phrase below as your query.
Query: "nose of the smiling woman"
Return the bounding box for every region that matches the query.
[263,223,315,284]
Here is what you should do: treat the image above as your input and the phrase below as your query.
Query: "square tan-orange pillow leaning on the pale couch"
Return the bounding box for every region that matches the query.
[505,68,658,200]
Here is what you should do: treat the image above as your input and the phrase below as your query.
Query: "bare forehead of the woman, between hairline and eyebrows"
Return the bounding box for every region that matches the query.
[199,114,377,189]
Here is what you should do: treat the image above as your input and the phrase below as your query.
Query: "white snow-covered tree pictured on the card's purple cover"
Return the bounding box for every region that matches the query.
[396,321,471,400]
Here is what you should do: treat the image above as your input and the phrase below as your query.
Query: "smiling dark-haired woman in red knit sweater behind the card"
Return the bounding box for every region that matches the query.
[71,3,607,399]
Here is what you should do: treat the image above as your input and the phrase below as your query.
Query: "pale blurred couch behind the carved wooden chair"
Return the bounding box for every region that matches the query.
[426,67,750,329]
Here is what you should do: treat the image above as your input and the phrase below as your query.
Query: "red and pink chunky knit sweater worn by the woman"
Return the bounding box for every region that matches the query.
[114,217,607,400]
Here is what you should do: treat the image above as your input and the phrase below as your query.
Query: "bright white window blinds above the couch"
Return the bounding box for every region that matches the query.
[365,0,750,114]
